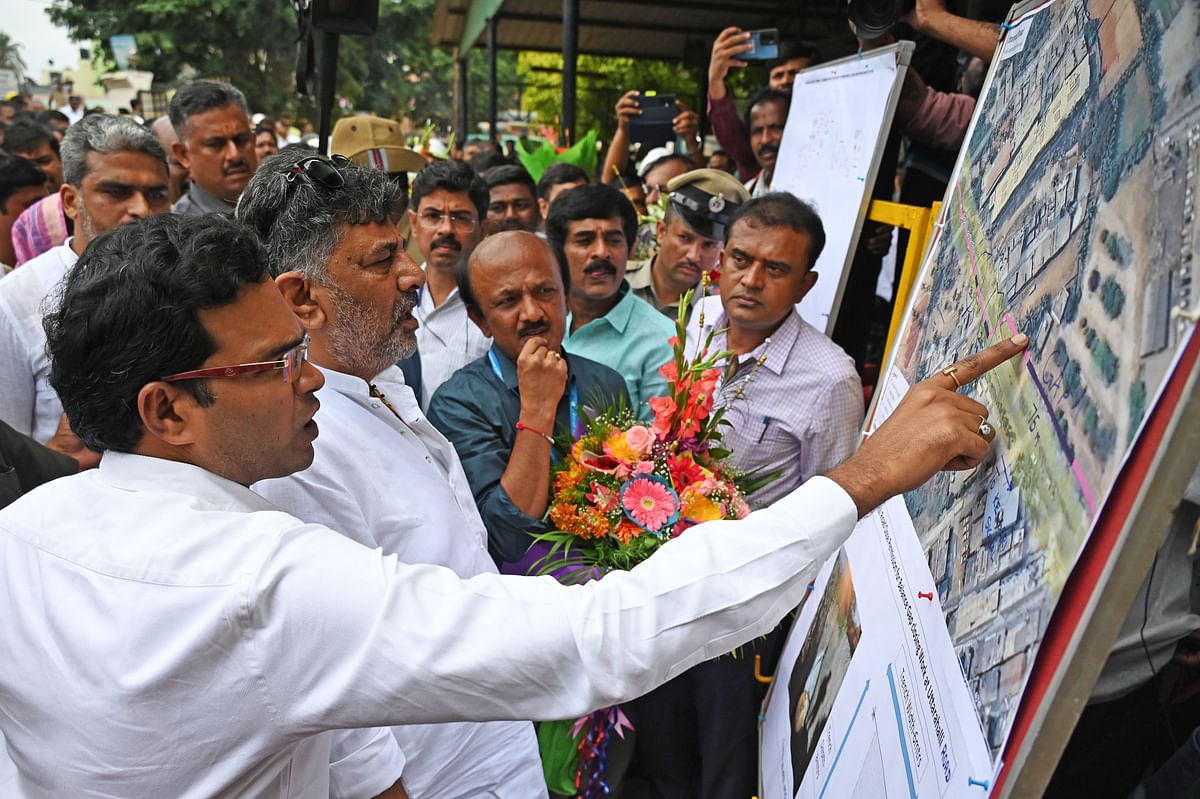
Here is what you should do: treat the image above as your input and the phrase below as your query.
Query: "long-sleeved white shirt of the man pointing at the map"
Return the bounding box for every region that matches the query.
[0,452,857,799]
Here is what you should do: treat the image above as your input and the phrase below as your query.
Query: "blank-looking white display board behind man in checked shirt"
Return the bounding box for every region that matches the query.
[770,42,912,334]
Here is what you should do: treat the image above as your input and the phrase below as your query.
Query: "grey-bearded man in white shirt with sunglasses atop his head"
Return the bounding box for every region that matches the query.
[238,151,546,799]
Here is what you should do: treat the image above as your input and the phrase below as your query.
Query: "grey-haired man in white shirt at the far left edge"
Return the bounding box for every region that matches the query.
[0,114,170,444]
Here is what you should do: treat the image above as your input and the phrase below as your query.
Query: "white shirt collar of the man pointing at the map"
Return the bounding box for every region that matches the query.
[100,452,278,511]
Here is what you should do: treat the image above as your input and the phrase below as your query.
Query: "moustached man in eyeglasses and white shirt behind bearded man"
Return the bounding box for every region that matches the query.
[408,161,492,410]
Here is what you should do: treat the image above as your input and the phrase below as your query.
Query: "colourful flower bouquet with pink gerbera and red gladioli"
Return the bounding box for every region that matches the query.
[530,292,776,798]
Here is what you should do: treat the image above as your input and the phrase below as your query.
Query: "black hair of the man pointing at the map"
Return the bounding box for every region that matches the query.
[42,214,268,452]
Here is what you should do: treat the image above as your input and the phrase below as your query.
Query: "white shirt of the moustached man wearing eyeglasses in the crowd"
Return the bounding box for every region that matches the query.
[413,275,492,410]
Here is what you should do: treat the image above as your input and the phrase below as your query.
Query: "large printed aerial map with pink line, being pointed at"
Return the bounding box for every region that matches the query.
[883,0,1200,752]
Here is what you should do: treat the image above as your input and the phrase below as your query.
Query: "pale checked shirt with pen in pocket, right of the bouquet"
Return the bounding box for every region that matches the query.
[688,296,864,509]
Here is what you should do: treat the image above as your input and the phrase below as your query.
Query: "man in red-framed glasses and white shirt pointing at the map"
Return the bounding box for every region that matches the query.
[0,208,1026,799]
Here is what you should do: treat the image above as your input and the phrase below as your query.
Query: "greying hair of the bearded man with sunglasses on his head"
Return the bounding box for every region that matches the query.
[236,148,406,283]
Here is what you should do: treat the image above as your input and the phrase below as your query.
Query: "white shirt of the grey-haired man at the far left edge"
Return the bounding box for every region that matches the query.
[0,239,79,444]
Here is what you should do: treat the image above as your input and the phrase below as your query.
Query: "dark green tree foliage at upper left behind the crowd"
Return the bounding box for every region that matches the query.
[49,0,516,125]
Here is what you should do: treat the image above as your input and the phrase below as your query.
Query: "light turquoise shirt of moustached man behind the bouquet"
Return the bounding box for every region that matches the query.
[563,281,674,419]
